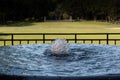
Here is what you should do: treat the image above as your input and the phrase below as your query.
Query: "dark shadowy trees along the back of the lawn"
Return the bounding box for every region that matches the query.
[0,0,120,24]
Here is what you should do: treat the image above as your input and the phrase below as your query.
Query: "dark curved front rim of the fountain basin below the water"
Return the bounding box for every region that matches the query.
[0,74,120,80]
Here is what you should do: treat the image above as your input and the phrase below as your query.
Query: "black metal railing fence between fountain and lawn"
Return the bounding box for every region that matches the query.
[0,33,120,46]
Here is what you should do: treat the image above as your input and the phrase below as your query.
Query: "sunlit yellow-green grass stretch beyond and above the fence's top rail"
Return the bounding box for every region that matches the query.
[0,21,120,33]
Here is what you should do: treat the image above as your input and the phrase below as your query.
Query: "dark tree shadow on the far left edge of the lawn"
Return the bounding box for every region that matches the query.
[0,22,34,27]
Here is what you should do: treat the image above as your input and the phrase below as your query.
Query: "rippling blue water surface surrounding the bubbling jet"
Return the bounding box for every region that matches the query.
[0,44,120,76]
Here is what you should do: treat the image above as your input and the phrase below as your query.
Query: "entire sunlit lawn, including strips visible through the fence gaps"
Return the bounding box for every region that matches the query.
[0,21,120,44]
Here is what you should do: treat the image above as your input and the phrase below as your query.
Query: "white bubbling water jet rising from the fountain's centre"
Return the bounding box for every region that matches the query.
[50,39,70,55]
